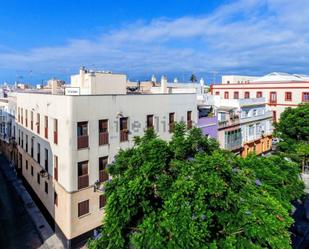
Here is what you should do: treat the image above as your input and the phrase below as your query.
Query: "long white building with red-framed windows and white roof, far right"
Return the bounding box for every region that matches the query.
[210,73,309,121]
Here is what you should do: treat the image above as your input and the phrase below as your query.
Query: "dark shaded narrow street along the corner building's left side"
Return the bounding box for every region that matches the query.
[0,156,42,249]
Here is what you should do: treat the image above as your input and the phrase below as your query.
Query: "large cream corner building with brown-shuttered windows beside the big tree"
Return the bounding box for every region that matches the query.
[14,69,197,248]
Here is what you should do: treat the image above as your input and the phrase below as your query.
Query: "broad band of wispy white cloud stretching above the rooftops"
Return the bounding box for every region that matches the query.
[0,0,309,80]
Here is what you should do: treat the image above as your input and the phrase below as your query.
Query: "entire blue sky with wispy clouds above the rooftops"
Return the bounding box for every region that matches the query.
[0,0,309,83]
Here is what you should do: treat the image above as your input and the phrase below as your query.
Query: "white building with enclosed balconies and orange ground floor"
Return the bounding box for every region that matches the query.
[213,96,273,157]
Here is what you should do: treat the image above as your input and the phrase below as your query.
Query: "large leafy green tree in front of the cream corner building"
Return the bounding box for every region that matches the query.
[88,124,302,249]
